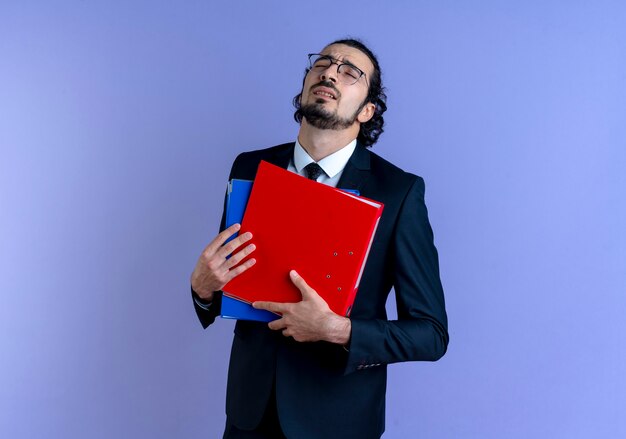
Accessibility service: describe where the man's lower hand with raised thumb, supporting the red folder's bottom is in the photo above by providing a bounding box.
[252,270,352,346]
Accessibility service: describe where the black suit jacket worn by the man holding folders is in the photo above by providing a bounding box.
[195,143,448,439]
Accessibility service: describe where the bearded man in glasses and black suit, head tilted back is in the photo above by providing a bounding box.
[191,39,448,439]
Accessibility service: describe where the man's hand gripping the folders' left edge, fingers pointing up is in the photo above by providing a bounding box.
[191,224,256,301]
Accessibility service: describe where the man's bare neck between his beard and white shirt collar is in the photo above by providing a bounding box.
[298,119,360,162]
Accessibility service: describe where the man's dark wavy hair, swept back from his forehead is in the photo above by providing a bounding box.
[293,38,387,147]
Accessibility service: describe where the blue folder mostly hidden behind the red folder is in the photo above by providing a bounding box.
[220,179,359,322]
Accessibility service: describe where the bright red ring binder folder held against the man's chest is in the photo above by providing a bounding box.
[223,162,383,316]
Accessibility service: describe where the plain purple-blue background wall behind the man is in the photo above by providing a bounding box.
[0,0,626,439]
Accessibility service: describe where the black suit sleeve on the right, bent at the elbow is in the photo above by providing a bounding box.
[345,177,449,374]
